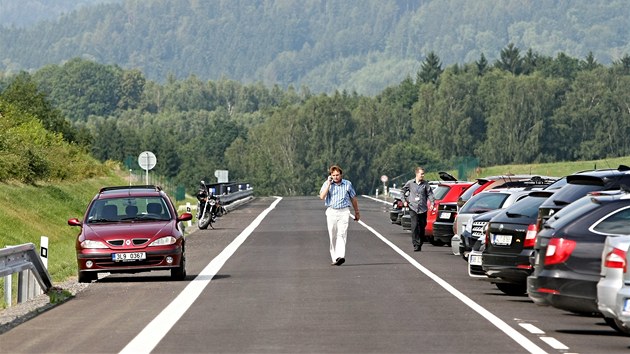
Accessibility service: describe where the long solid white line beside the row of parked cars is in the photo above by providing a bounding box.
[359,220,547,353]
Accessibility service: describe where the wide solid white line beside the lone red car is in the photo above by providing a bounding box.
[120,197,282,354]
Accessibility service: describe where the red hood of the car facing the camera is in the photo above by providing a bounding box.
[83,221,174,240]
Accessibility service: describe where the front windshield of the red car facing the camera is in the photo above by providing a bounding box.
[87,197,171,223]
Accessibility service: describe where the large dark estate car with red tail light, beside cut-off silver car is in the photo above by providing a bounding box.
[527,191,630,314]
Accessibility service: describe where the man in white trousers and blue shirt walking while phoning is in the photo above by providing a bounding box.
[319,165,360,266]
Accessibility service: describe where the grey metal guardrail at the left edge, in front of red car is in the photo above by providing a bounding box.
[0,243,53,306]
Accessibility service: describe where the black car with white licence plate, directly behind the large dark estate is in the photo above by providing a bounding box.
[486,190,554,295]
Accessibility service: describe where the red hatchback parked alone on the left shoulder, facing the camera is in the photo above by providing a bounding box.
[68,185,192,283]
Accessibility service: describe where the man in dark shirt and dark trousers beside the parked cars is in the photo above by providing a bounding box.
[403,166,435,252]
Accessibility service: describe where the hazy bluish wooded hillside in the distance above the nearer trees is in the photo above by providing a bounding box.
[0,0,630,94]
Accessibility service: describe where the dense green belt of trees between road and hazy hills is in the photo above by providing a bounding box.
[0,44,630,195]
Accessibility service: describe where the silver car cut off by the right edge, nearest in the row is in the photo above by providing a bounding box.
[597,235,630,334]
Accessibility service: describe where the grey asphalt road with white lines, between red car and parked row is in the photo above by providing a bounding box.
[0,197,630,353]
